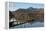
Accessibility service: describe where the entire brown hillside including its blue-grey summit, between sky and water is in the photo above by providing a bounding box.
[9,7,44,22]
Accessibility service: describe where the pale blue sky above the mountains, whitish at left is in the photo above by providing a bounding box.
[8,2,44,11]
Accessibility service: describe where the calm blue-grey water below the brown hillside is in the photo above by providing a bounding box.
[11,22,44,29]
